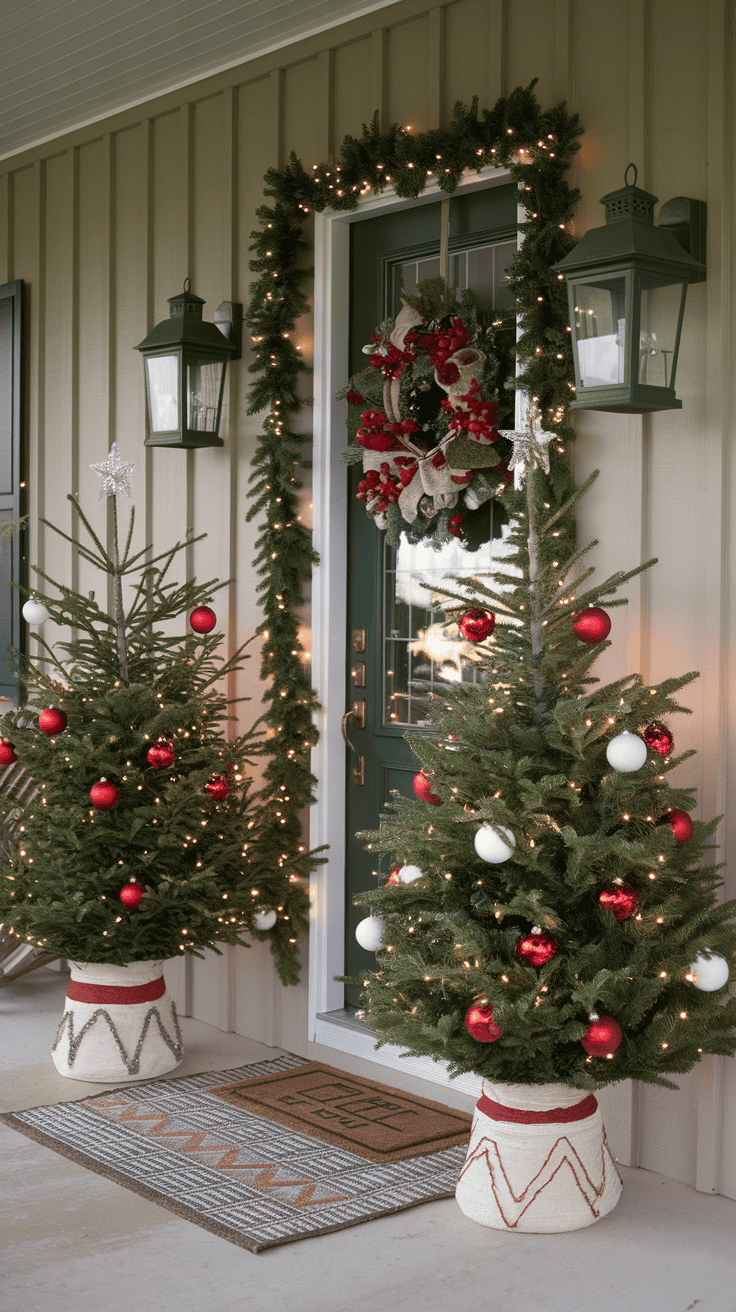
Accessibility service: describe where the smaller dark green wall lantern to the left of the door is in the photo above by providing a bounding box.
[135,278,243,449]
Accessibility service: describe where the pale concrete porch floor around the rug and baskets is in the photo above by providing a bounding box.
[0,970,736,1312]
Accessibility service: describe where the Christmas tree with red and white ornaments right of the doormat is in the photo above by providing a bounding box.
[348,408,736,1090]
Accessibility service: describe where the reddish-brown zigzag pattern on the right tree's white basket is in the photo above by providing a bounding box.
[458,1127,621,1229]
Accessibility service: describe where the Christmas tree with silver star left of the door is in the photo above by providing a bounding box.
[0,445,307,983]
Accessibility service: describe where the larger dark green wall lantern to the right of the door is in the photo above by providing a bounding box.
[552,164,706,415]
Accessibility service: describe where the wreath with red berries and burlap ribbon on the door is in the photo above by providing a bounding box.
[344,278,514,550]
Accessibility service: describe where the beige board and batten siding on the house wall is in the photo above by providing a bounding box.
[0,0,736,1198]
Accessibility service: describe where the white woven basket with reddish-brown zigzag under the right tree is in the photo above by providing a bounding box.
[455,1080,622,1235]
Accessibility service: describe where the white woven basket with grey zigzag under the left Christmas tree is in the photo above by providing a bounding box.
[51,962,184,1084]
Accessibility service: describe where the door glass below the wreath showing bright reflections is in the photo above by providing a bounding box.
[383,512,509,728]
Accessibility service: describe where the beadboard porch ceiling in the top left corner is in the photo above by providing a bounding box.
[0,0,394,159]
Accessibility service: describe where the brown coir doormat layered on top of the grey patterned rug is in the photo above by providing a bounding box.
[210,1061,471,1161]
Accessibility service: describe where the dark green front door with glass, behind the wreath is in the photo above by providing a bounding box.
[344,185,517,1006]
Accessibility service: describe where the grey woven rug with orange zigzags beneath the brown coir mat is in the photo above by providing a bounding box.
[0,1056,471,1253]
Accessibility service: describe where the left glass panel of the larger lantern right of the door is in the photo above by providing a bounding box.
[572,274,627,387]
